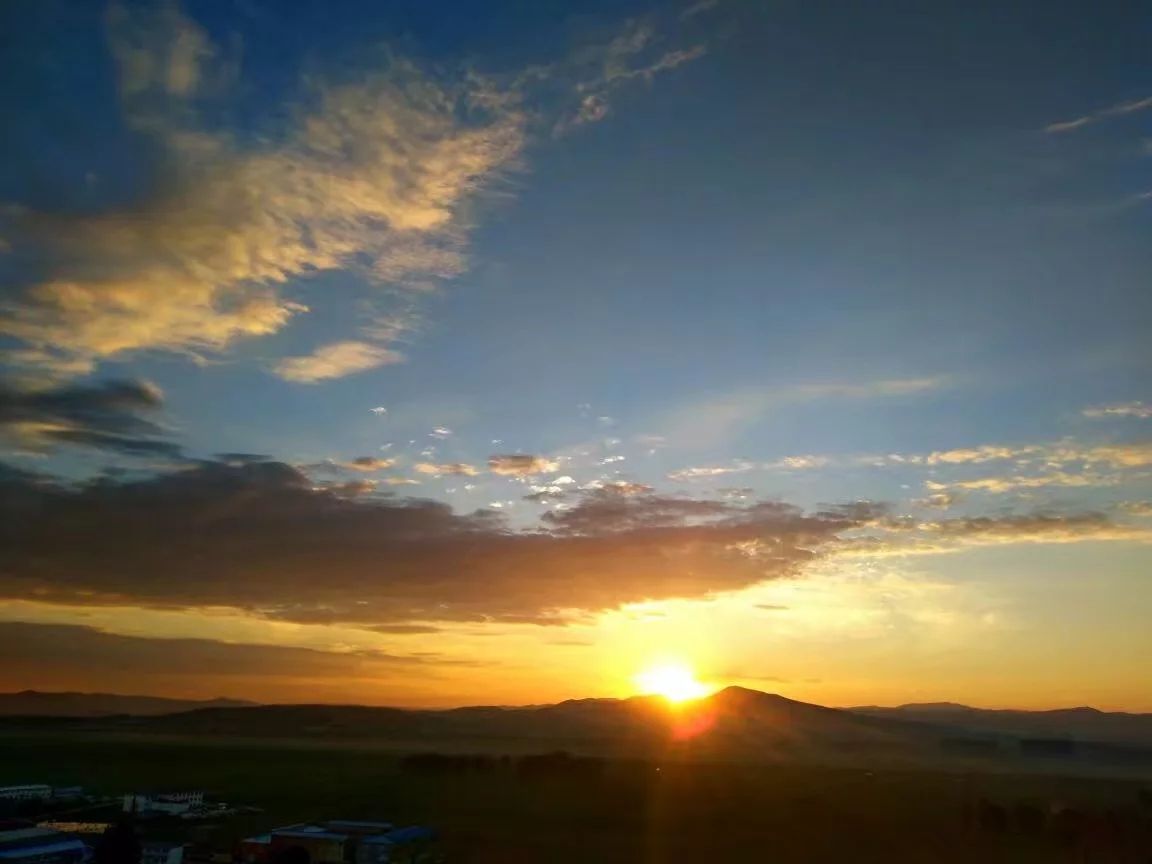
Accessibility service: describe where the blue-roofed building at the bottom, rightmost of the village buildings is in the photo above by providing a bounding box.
[236,819,435,864]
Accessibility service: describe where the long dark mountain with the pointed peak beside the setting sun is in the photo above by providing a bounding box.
[0,687,938,760]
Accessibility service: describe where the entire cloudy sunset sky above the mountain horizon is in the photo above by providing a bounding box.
[0,0,1152,712]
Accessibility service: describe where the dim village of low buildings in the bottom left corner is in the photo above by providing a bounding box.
[0,783,444,864]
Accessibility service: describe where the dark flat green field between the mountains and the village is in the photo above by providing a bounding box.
[0,735,1150,864]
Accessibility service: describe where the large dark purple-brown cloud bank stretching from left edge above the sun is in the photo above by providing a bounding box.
[0,462,863,624]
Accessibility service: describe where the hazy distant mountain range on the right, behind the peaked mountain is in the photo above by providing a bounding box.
[847,703,1152,746]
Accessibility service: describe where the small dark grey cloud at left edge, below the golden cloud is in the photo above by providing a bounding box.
[0,380,181,457]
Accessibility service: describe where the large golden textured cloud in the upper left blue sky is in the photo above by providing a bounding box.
[0,5,524,382]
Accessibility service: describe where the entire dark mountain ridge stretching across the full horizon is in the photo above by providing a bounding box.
[0,687,1152,771]
